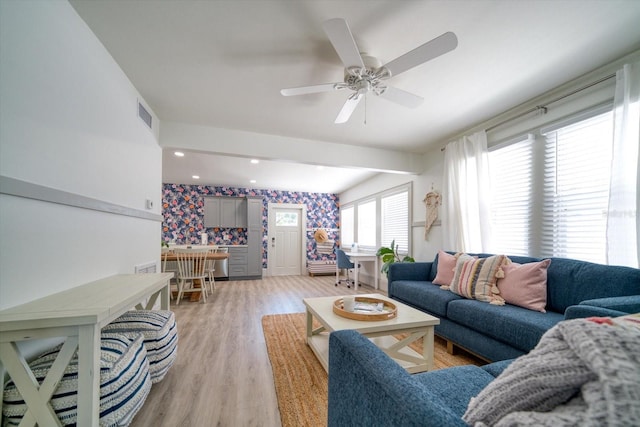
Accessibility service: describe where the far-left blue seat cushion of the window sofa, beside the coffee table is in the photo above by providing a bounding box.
[393,280,462,316]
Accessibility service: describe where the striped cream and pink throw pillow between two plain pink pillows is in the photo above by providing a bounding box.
[443,254,507,304]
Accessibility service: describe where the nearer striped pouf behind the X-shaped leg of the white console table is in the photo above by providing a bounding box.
[2,333,151,427]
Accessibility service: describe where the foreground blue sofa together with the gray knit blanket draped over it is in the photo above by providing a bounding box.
[327,309,640,427]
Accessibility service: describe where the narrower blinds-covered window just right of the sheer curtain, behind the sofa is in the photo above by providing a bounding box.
[489,135,537,255]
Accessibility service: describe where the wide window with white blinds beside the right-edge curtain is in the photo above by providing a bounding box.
[541,111,613,263]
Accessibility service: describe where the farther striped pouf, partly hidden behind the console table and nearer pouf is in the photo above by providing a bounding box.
[102,310,178,384]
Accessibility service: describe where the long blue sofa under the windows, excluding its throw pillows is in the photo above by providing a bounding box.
[388,252,640,361]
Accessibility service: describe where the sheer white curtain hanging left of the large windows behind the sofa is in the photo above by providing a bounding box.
[442,131,491,252]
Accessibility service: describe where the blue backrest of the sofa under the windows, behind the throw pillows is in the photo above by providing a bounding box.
[429,251,640,313]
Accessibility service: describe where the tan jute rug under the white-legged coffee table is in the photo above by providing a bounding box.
[262,313,482,427]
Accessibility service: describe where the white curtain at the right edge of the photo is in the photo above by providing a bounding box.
[607,62,640,268]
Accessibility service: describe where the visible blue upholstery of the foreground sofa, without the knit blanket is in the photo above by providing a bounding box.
[327,330,511,427]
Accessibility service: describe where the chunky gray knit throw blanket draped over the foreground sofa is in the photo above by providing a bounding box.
[463,317,640,427]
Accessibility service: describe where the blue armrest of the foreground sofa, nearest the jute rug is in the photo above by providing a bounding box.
[327,330,466,427]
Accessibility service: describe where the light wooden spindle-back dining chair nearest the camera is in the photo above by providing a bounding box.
[174,248,209,304]
